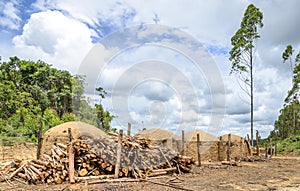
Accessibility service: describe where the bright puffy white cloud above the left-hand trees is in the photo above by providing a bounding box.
[13,11,93,72]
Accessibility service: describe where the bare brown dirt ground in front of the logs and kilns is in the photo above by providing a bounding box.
[0,156,300,191]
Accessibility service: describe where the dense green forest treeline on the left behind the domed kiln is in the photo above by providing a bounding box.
[0,57,114,141]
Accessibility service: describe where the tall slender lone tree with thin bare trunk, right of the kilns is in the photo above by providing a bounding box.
[229,4,263,145]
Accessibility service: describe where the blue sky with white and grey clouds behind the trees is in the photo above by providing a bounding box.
[0,0,300,138]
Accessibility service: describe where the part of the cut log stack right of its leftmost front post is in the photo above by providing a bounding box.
[74,136,195,178]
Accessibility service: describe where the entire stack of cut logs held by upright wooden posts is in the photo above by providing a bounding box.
[0,133,195,184]
